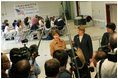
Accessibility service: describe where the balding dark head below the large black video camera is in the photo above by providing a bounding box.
[10,59,31,78]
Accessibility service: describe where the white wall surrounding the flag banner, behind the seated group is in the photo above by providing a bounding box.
[1,1,59,23]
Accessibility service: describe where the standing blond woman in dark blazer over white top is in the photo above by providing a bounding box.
[74,26,93,65]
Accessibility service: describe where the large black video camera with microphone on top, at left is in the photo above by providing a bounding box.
[10,39,38,64]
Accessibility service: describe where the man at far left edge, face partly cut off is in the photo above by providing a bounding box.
[1,53,10,78]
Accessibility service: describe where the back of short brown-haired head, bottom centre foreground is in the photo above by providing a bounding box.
[44,58,60,78]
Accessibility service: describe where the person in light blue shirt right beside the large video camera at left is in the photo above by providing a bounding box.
[29,44,41,78]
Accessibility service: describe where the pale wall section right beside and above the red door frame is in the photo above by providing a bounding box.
[92,1,117,28]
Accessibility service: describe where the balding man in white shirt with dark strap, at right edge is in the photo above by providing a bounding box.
[97,33,117,78]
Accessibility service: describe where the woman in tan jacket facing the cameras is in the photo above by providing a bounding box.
[50,30,66,56]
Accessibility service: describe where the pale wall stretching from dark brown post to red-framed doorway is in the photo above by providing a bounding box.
[74,1,117,28]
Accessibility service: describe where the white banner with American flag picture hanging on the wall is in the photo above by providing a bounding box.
[15,3,39,17]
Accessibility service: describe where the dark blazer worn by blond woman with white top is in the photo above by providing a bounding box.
[74,34,93,63]
